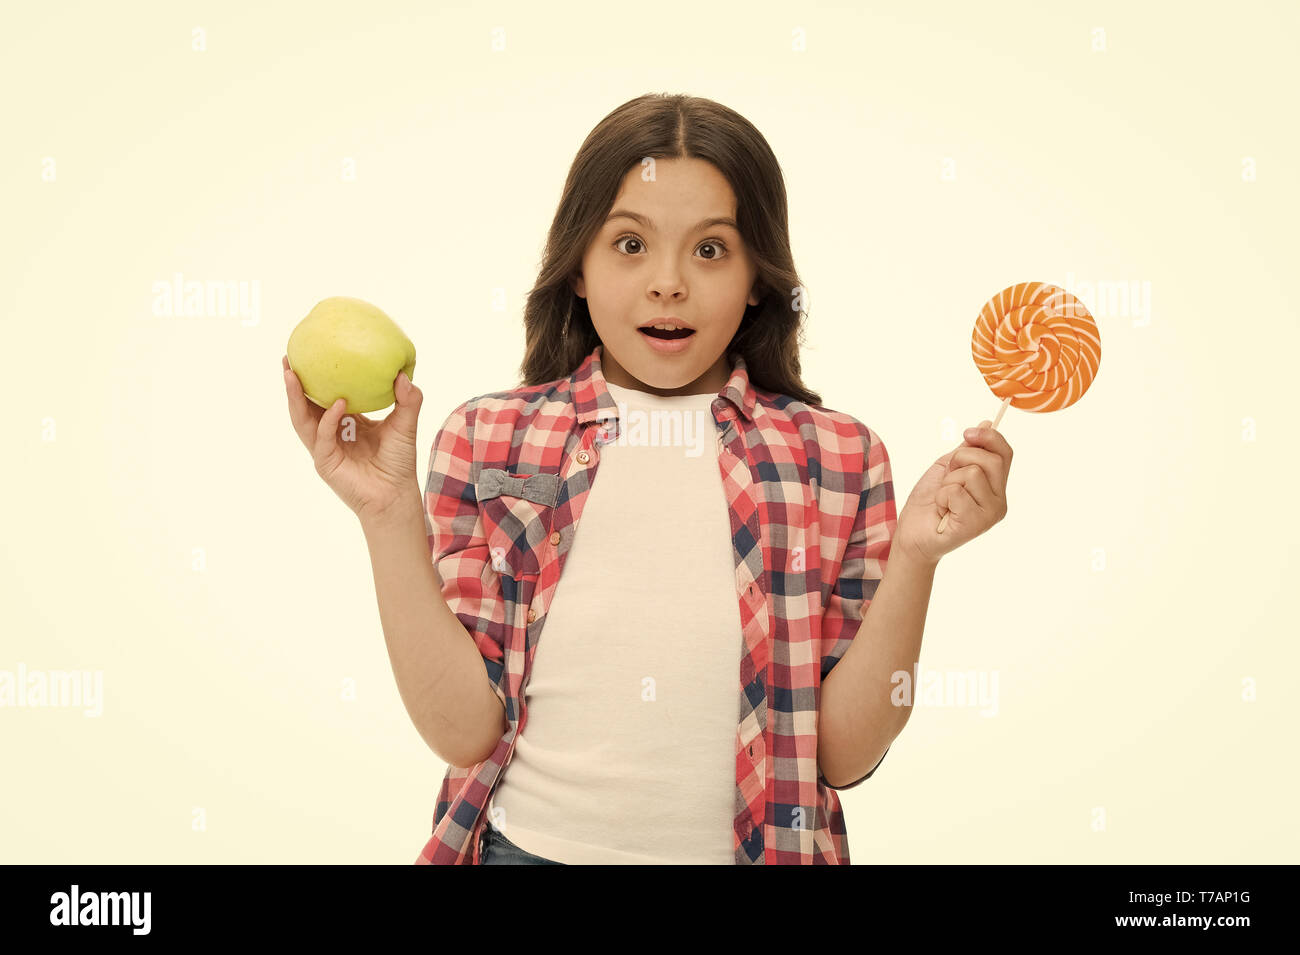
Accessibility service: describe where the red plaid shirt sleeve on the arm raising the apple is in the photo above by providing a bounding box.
[424,399,506,706]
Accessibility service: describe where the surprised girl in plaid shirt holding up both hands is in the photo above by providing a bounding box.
[285,95,1011,864]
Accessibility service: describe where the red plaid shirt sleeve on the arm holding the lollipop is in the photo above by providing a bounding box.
[818,422,898,790]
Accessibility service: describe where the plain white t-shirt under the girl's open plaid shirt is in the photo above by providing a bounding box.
[488,382,744,865]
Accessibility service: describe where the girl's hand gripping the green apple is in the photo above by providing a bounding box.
[282,355,424,521]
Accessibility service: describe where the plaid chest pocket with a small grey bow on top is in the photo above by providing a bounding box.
[475,468,559,579]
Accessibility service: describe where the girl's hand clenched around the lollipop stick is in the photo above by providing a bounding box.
[893,421,1011,564]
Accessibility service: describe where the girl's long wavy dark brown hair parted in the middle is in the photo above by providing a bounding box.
[520,94,822,405]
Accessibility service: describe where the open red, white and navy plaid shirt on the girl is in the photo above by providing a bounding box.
[416,346,897,865]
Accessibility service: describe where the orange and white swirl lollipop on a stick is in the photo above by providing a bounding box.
[939,282,1101,534]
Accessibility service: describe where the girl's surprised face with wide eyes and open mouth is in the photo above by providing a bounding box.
[573,159,759,396]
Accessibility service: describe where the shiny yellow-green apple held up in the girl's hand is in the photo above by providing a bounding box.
[285,296,415,414]
